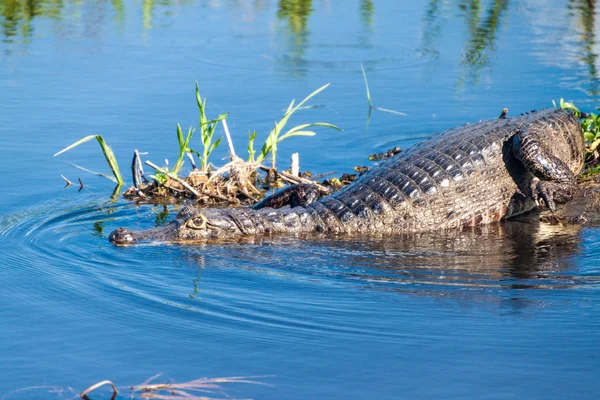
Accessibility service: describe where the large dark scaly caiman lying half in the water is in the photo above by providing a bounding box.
[109,109,584,245]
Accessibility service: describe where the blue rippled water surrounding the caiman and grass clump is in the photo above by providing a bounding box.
[0,0,600,399]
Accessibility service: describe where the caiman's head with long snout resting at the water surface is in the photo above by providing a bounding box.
[108,206,241,246]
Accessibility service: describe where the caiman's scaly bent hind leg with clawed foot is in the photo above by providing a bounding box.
[512,124,577,211]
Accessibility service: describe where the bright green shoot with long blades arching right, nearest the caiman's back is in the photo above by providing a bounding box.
[248,83,342,168]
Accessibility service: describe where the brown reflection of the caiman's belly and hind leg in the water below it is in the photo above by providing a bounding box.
[312,221,580,288]
